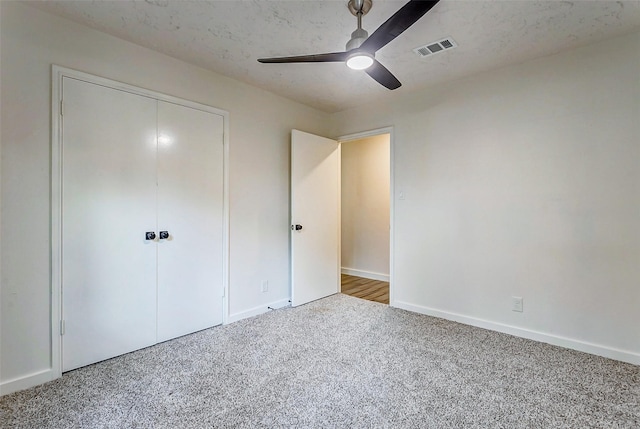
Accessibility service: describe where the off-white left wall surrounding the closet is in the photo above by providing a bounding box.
[0,2,328,393]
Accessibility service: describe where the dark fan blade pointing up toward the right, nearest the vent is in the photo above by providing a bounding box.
[360,0,440,53]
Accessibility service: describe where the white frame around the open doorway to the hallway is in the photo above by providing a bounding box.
[335,126,395,307]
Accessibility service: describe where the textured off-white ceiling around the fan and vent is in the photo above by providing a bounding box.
[30,0,640,112]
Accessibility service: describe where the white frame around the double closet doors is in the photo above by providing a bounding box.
[50,64,229,380]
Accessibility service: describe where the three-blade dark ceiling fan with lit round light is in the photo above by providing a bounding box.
[258,0,440,89]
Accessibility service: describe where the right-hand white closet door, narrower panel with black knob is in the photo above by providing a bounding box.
[158,101,224,341]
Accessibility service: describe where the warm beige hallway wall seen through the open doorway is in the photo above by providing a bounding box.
[341,134,390,281]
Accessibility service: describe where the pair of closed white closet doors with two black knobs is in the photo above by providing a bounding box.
[60,76,224,371]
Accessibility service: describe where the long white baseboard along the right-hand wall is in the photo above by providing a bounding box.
[391,301,640,365]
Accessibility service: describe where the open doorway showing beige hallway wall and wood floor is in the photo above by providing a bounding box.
[340,129,392,304]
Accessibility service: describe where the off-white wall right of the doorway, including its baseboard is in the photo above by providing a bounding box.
[333,34,640,364]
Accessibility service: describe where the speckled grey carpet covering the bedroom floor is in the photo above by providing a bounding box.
[0,294,640,429]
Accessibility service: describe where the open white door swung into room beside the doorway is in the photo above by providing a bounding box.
[291,130,340,307]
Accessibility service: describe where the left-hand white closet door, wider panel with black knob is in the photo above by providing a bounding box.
[62,78,157,371]
